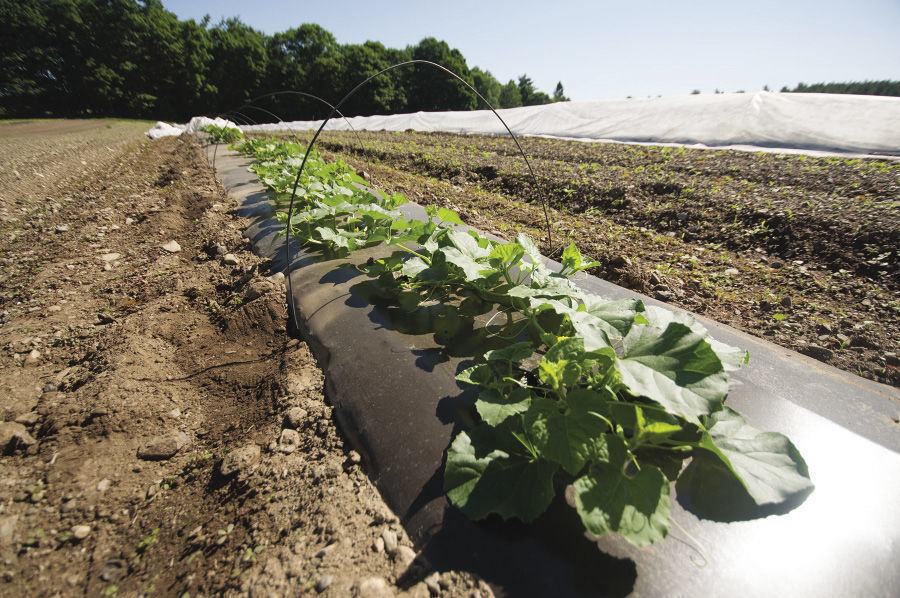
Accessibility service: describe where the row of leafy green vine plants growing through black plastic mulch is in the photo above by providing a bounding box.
[213,132,812,546]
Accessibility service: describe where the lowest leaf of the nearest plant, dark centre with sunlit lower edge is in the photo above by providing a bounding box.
[574,463,669,546]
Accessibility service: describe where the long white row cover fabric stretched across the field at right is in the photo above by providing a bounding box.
[241,91,900,155]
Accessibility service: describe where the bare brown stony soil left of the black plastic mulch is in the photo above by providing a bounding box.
[0,121,491,598]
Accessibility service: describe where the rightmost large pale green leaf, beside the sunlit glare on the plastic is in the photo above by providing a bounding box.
[699,407,812,505]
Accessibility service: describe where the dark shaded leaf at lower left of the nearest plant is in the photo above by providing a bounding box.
[444,428,559,522]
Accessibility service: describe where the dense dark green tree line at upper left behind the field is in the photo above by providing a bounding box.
[0,0,568,122]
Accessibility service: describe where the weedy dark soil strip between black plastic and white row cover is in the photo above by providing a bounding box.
[292,131,900,387]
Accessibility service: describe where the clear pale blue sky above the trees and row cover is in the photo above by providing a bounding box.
[162,0,900,100]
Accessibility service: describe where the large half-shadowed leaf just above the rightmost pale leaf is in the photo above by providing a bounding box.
[614,322,728,424]
